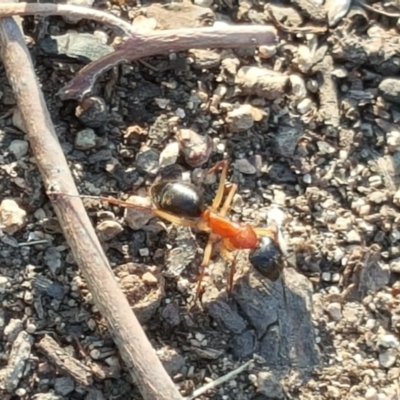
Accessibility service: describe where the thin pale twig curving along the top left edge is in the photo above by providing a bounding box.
[0,3,136,35]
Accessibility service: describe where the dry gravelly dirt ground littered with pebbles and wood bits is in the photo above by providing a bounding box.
[0,0,400,400]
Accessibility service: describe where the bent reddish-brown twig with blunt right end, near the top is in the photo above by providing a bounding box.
[59,25,277,100]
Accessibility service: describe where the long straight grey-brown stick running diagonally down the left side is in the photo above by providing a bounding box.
[0,14,182,400]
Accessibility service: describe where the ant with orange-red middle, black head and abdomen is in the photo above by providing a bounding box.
[52,160,287,299]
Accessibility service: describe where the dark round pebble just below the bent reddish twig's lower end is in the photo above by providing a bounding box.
[75,96,108,128]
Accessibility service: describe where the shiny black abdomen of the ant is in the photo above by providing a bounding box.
[150,181,203,218]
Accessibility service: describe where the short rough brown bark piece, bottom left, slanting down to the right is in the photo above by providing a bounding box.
[37,335,93,386]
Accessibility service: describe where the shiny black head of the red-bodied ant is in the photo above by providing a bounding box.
[249,236,283,282]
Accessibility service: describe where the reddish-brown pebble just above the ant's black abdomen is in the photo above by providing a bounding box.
[176,129,213,168]
